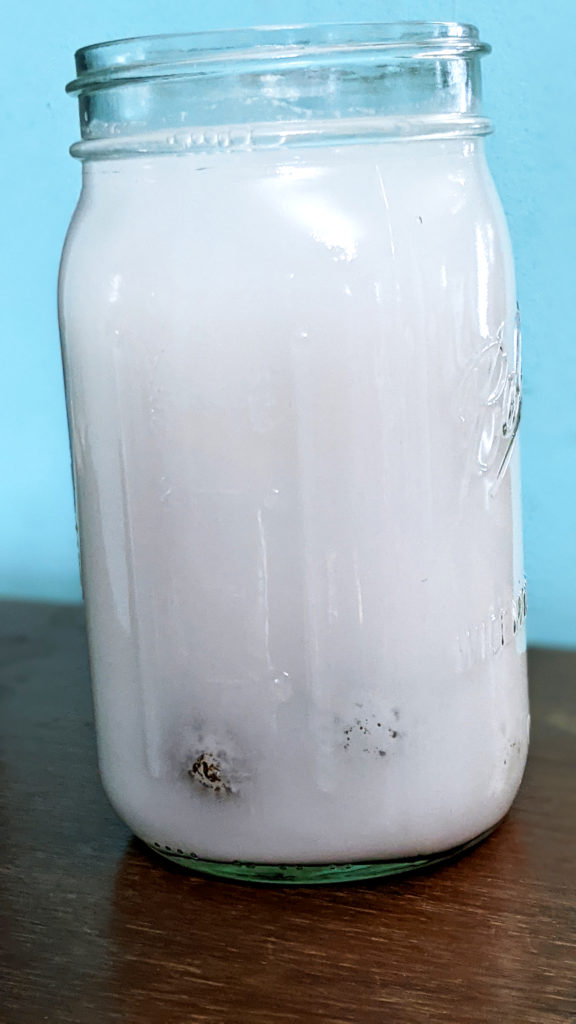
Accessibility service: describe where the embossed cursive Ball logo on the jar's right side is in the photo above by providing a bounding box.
[460,313,522,494]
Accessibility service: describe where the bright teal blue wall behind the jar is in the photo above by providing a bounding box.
[0,0,576,645]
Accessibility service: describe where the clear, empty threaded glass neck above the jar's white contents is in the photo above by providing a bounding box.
[68,23,490,159]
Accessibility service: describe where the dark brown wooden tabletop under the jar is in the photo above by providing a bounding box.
[0,603,576,1024]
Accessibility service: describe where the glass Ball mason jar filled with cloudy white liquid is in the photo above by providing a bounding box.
[60,23,529,883]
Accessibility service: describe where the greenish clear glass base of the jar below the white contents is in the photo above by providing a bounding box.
[147,822,499,886]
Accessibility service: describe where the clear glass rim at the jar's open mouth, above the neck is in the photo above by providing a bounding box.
[67,22,490,94]
